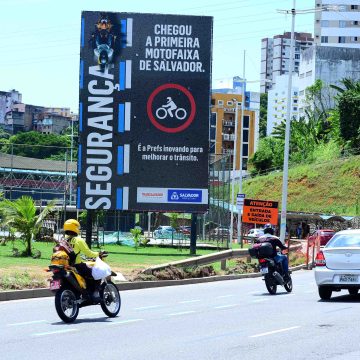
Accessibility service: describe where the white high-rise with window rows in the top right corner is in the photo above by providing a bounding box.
[314,0,360,48]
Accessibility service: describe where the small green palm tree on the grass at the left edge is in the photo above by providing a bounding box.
[0,196,54,256]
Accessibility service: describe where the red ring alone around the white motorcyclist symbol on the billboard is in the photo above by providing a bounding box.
[146,84,196,133]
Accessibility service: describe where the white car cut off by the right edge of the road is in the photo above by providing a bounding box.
[315,229,360,300]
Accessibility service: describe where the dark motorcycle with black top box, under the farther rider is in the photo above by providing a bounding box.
[249,242,293,295]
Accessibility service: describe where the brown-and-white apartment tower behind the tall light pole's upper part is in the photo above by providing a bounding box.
[260,32,314,93]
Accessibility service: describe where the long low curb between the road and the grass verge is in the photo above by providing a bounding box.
[0,264,307,302]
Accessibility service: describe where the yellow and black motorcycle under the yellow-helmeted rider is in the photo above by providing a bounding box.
[46,250,121,323]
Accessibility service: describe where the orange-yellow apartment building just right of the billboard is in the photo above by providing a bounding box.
[209,93,257,170]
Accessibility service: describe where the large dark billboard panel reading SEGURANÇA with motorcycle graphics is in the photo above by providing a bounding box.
[77,11,212,212]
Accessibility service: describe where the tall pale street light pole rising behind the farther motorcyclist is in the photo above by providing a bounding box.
[280,0,296,243]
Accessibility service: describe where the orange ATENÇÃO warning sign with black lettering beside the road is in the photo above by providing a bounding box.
[242,199,279,225]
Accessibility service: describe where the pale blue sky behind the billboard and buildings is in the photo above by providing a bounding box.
[0,0,315,113]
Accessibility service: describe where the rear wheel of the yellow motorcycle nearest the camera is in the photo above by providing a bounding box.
[55,288,79,323]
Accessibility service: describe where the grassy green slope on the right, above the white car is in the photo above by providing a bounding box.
[235,156,360,216]
